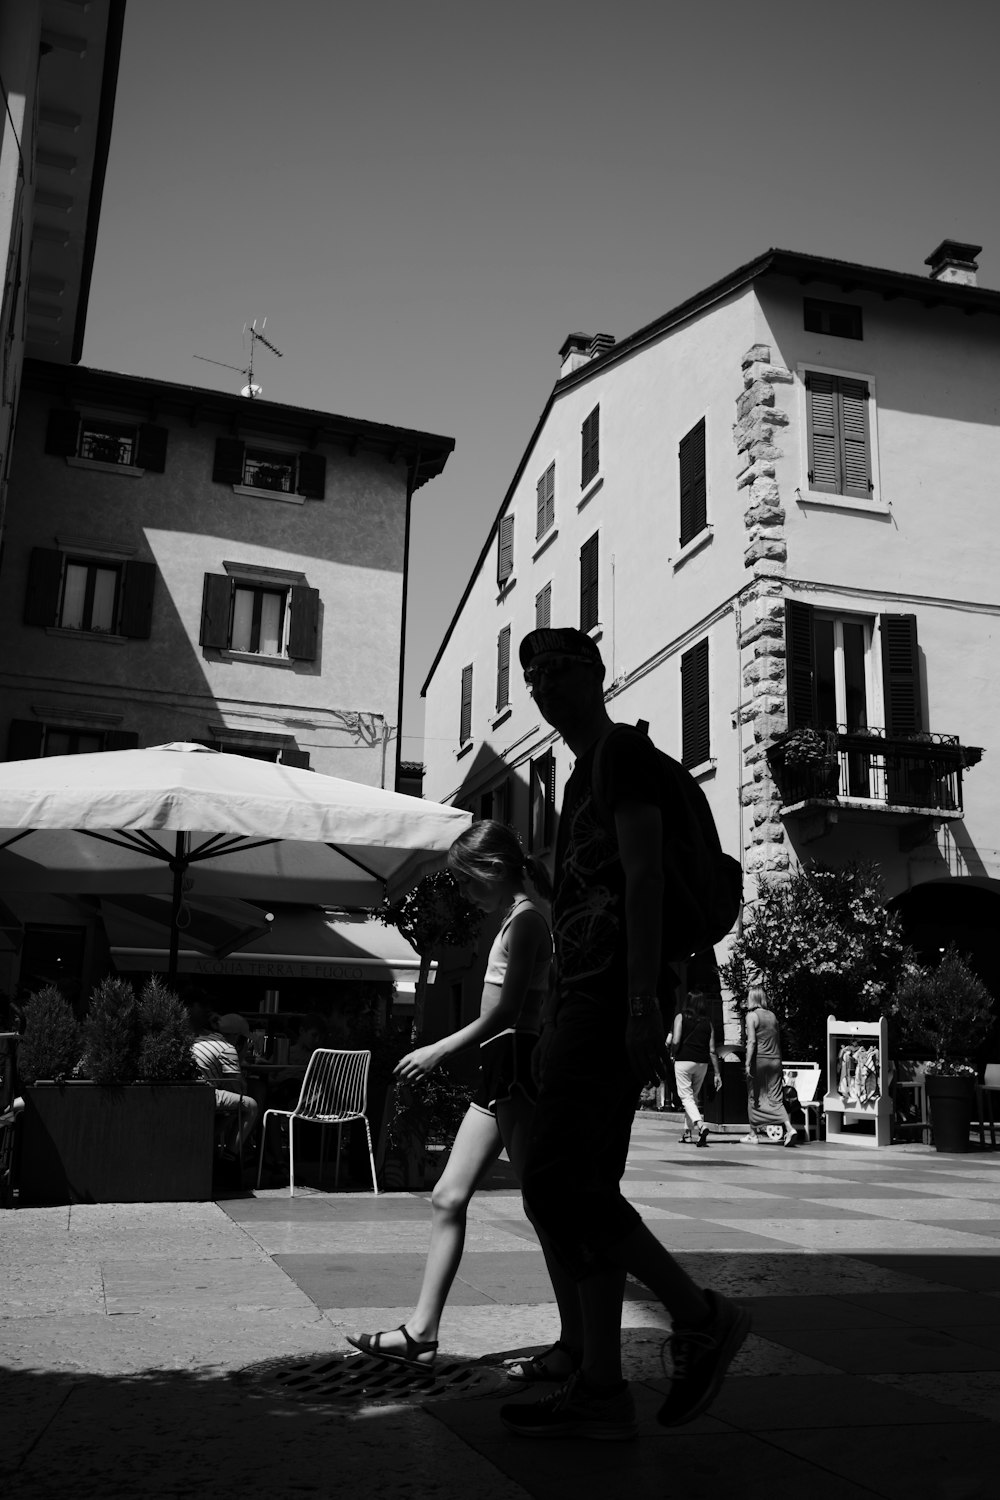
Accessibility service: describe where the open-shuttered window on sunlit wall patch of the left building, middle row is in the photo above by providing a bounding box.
[199,564,319,662]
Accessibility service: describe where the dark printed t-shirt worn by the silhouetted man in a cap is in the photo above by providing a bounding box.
[552,732,663,1014]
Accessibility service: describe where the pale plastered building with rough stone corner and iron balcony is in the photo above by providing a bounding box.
[424,242,1000,1026]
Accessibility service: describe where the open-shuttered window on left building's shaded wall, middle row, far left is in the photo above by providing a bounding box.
[24,548,156,641]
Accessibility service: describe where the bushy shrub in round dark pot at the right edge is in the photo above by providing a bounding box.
[892,944,994,1151]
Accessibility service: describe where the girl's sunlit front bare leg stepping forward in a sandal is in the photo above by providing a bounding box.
[370,1109,502,1353]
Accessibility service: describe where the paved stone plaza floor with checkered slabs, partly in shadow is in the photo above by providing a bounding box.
[0,1115,1000,1500]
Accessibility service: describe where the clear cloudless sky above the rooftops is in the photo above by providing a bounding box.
[84,0,1000,759]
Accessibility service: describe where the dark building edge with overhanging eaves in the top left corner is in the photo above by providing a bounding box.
[0,0,124,548]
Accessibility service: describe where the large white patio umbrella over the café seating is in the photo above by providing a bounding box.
[0,744,469,975]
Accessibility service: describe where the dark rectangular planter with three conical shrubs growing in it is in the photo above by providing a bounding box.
[18,978,214,1203]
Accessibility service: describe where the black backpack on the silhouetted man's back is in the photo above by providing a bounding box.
[591,725,744,963]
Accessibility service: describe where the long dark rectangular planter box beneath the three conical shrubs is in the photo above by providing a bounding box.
[18,1083,216,1205]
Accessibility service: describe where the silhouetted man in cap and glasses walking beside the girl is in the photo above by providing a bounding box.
[501,629,750,1440]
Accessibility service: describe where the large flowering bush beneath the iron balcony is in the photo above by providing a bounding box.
[720,861,913,1058]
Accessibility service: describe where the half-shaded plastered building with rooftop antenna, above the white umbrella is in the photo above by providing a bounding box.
[0,360,453,788]
